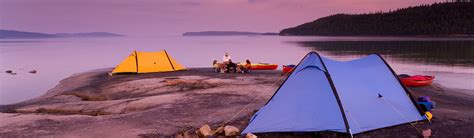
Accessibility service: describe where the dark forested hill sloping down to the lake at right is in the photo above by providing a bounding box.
[280,2,474,36]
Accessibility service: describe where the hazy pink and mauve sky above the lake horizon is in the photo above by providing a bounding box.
[0,0,442,36]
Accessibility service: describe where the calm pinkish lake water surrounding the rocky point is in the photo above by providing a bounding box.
[0,36,474,104]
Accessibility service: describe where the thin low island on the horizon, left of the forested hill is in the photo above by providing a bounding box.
[183,31,278,36]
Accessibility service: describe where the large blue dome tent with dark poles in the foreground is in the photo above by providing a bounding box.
[242,52,426,135]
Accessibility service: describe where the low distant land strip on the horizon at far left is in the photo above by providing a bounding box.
[0,29,125,39]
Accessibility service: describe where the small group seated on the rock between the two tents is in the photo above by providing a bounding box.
[212,53,252,73]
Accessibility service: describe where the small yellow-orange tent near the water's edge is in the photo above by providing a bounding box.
[111,50,186,75]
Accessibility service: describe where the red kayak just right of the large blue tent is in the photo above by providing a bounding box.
[398,74,434,87]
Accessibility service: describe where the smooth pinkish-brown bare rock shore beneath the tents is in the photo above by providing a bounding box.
[0,68,474,137]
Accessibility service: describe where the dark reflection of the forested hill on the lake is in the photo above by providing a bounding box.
[295,41,474,67]
